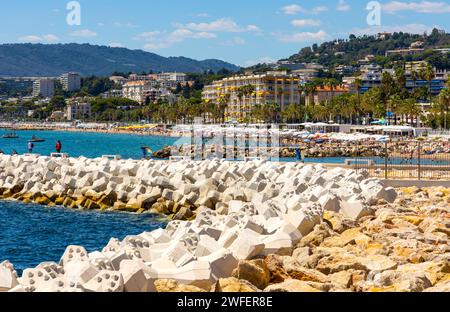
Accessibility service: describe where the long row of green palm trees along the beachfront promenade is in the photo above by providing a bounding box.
[135,66,450,128]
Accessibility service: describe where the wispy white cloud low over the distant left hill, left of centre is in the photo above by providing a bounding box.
[138,28,217,50]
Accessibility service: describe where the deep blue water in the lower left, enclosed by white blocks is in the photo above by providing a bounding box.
[0,201,166,274]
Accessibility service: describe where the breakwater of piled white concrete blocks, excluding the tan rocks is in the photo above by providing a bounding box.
[0,155,404,291]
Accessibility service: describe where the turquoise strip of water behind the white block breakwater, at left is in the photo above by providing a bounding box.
[0,130,187,159]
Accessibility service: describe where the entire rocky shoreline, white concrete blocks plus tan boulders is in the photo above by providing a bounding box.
[0,155,450,292]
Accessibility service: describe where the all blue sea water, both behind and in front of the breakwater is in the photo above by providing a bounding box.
[0,130,444,273]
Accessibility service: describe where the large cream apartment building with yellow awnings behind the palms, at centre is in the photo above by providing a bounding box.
[202,72,302,122]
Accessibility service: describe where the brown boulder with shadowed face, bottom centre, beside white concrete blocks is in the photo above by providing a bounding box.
[232,259,270,289]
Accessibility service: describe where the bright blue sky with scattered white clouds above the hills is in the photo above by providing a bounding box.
[0,0,450,66]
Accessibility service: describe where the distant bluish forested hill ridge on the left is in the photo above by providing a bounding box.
[0,43,239,77]
